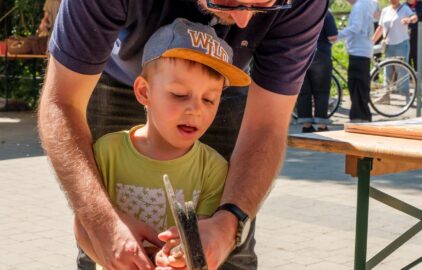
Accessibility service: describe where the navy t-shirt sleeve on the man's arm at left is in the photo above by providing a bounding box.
[49,0,127,75]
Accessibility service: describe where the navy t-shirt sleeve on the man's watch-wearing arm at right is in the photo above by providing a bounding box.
[251,0,328,95]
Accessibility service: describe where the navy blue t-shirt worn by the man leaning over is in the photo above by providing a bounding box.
[49,0,327,95]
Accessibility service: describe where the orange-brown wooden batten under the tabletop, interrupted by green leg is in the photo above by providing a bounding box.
[345,155,422,177]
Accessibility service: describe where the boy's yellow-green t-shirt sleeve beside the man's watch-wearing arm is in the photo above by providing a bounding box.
[196,156,228,216]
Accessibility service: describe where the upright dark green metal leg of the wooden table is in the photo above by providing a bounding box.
[354,158,372,270]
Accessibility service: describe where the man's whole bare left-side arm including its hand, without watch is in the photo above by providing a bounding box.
[38,57,160,269]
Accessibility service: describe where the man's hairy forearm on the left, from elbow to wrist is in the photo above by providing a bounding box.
[39,101,116,228]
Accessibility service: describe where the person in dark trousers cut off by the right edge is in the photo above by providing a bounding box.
[406,0,422,71]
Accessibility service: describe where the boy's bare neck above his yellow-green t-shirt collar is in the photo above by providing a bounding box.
[130,125,193,160]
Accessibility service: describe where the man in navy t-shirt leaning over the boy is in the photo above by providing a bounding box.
[39,0,327,269]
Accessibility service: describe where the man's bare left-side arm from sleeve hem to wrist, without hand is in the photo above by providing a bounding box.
[38,57,112,222]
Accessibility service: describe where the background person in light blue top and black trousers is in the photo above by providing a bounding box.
[338,0,376,122]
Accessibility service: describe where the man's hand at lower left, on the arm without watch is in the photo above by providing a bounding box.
[85,210,163,270]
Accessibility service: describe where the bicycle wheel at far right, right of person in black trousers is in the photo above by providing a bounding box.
[369,59,416,117]
